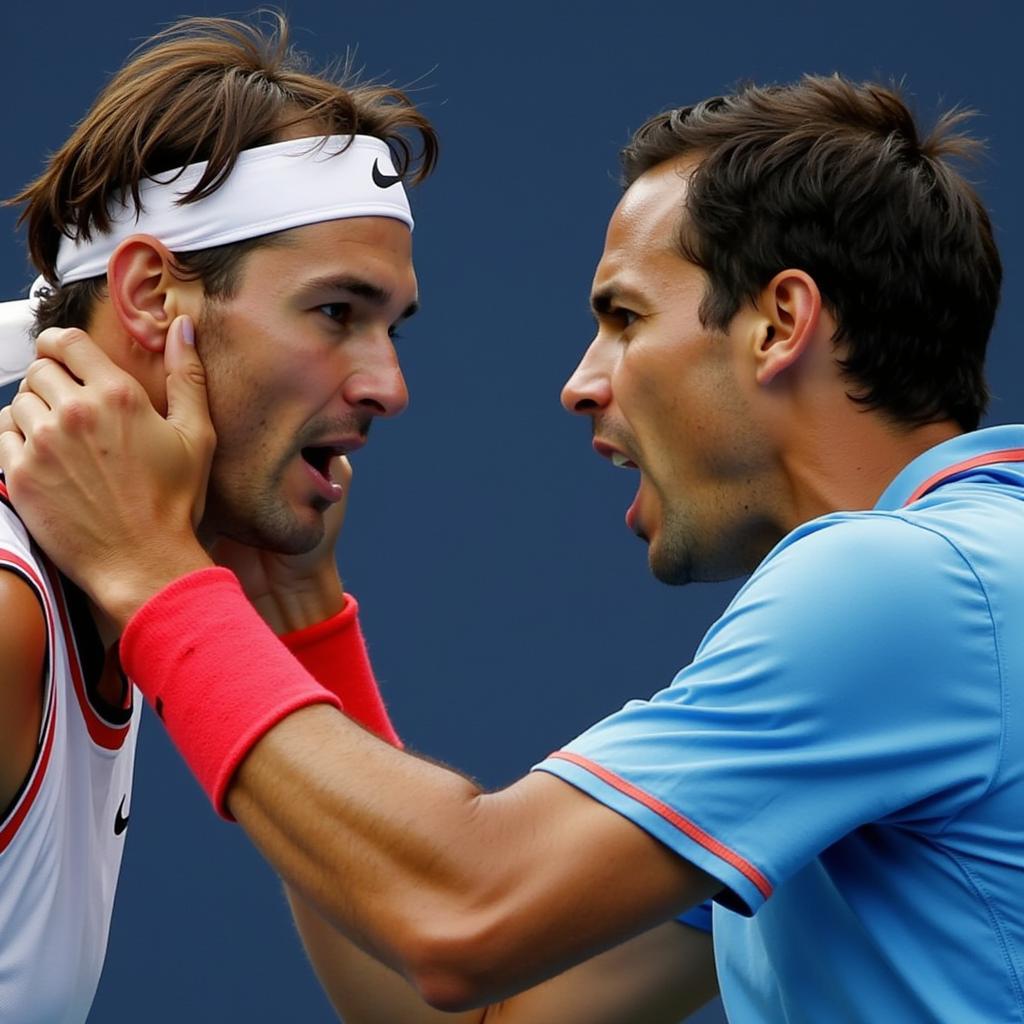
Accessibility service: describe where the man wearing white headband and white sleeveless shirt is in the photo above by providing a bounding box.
[0,19,437,1024]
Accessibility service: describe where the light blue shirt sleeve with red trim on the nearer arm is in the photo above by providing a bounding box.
[536,513,1001,913]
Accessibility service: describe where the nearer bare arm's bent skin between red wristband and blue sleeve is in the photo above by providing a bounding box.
[229,707,720,1010]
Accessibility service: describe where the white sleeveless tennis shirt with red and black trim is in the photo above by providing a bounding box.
[0,482,141,1024]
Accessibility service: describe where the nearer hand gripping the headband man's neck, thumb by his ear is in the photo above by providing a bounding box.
[0,316,215,626]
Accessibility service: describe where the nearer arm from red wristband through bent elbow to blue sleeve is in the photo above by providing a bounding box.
[122,569,717,1009]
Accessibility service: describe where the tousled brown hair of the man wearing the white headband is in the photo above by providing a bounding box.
[8,12,438,330]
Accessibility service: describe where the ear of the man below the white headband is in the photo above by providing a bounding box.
[106,234,202,352]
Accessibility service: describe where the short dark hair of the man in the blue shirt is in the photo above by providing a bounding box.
[622,75,1002,430]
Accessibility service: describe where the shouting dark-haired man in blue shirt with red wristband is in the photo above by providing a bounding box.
[0,77,1024,1024]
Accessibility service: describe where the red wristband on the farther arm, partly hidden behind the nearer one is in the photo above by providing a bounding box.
[281,594,402,749]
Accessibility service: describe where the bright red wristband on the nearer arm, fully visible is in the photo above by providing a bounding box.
[121,568,341,821]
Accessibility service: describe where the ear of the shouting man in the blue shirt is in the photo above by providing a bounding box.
[755,269,821,384]
